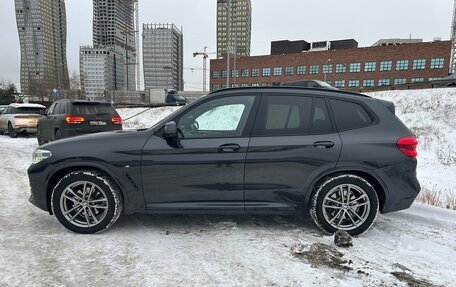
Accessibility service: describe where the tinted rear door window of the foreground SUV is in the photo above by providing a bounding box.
[253,95,332,136]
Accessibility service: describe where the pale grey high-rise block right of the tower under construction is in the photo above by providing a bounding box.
[143,24,184,91]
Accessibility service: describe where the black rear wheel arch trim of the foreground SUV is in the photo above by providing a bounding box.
[305,168,388,212]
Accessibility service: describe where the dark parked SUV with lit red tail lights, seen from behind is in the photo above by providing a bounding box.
[37,100,122,145]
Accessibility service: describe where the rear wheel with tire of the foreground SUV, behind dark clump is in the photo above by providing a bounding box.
[310,174,379,235]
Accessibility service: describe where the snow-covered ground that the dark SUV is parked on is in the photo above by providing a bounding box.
[0,89,456,286]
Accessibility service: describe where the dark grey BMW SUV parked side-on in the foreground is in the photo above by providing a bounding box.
[28,87,420,235]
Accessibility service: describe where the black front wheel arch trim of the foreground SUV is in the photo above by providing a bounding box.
[46,164,126,215]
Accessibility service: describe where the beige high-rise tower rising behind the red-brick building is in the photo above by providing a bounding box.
[217,0,252,58]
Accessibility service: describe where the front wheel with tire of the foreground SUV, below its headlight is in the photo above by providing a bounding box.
[51,170,122,234]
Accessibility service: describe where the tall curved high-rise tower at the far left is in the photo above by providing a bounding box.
[15,0,69,94]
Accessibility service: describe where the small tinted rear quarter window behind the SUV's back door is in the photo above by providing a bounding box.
[331,100,373,131]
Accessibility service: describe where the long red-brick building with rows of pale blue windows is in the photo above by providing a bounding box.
[210,39,451,91]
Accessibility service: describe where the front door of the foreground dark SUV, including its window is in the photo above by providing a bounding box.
[142,94,258,211]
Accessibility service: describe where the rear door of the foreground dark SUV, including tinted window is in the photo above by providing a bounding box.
[245,93,341,213]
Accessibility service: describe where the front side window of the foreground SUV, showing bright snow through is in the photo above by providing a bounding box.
[177,96,255,138]
